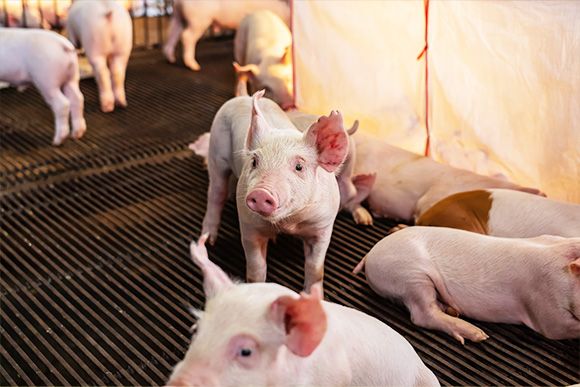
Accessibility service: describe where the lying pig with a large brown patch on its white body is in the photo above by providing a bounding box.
[415,189,580,238]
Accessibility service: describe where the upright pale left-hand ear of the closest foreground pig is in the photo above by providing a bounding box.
[189,233,233,299]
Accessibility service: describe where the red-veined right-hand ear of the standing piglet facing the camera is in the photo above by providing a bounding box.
[304,111,348,172]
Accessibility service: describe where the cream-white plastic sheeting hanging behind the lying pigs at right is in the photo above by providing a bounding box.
[293,0,580,202]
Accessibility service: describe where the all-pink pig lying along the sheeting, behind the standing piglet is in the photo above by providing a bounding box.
[288,112,541,224]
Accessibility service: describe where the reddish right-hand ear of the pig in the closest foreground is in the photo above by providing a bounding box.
[270,283,326,357]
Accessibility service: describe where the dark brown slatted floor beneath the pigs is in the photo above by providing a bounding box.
[0,41,580,385]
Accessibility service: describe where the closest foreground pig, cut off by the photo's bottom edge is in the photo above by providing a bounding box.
[167,235,439,386]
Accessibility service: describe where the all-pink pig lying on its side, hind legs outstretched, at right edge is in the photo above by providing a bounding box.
[354,226,580,343]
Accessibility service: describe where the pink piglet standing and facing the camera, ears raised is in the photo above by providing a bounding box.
[203,90,348,289]
